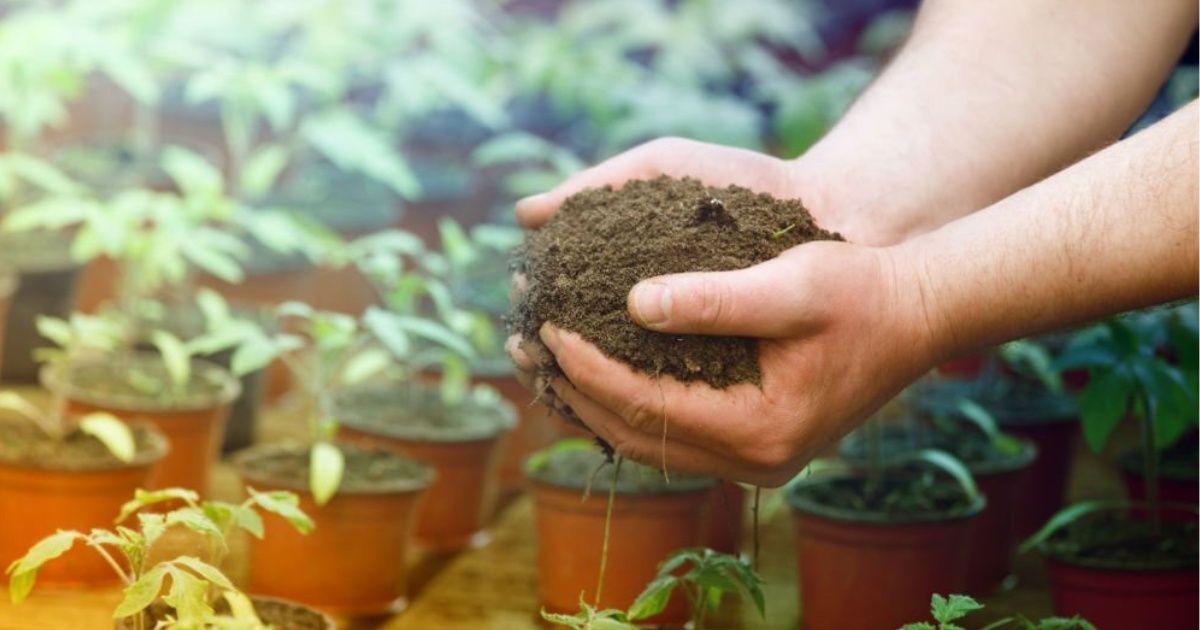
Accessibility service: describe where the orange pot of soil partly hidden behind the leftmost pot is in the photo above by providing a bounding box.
[42,353,240,494]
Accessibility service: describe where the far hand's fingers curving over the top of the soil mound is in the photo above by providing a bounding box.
[515,138,793,229]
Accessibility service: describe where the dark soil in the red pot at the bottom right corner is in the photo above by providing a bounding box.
[1039,512,1200,569]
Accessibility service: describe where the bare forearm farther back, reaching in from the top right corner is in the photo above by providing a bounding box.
[797,0,1196,244]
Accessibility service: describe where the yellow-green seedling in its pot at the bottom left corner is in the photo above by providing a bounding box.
[7,488,335,630]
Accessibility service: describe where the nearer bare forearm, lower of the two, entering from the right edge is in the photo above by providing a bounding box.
[892,102,1198,356]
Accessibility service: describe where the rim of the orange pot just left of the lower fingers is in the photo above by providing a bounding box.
[334,382,517,444]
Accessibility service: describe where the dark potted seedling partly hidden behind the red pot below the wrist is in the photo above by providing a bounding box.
[841,379,1037,594]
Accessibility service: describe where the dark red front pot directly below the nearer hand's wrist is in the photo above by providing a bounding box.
[788,479,984,630]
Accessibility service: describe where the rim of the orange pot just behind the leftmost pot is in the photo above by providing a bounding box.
[38,350,241,413]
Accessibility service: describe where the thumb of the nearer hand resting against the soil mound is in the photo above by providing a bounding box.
[628,257,814,337]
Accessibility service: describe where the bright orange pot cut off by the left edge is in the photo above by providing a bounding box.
[0,426,168,586]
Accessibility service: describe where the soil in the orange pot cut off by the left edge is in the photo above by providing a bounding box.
[0,419,167,470]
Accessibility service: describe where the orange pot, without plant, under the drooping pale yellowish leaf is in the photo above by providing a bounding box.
[233,446,430,616]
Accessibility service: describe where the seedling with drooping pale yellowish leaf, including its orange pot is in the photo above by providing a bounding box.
[226,302,432,616]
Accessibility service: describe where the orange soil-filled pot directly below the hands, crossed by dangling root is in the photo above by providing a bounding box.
[529,450,716,625]
